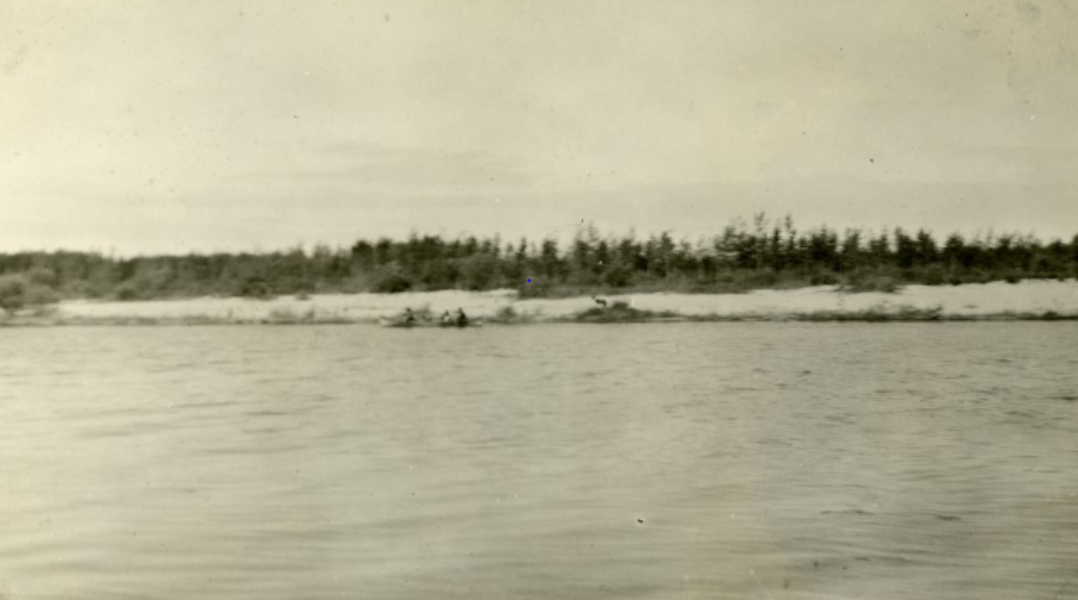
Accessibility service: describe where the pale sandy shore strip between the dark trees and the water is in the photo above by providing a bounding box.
[5,280,1078,325]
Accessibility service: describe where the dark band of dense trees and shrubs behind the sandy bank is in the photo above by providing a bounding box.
[0,214,1078,304]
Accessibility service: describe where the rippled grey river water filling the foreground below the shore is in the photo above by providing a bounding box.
[0,323,1078,600]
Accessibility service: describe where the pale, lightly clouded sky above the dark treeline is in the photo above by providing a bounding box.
[0,0,1078,255]
